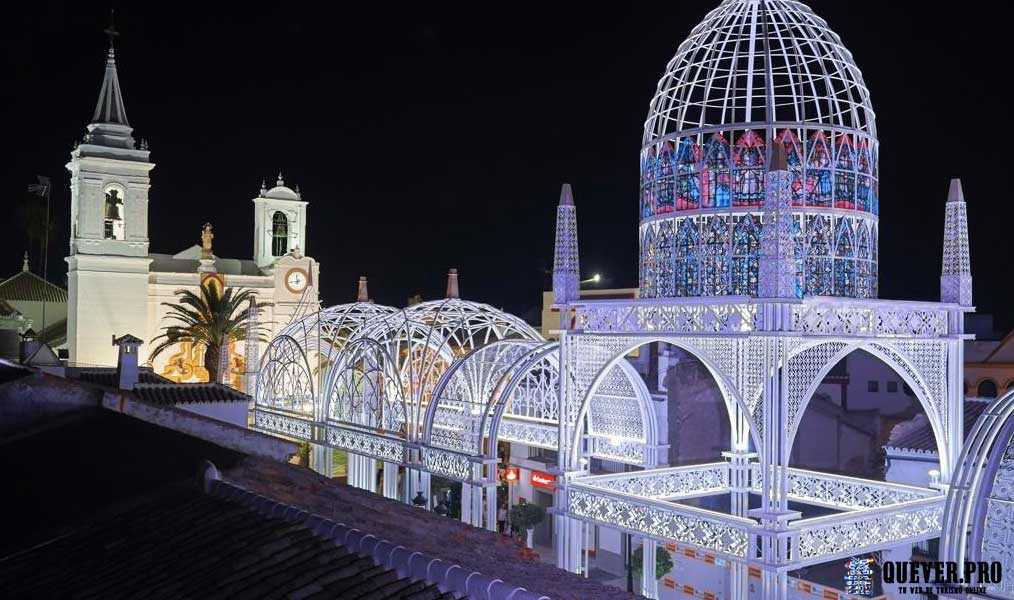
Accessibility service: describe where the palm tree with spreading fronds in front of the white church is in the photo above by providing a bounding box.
[149,286,267,382]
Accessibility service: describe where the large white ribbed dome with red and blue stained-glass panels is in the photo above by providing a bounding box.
[640,0,879,298]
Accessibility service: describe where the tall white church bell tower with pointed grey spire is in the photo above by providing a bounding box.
[66,25,155,365]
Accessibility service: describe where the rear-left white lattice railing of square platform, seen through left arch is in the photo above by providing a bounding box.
[577,462,729,500]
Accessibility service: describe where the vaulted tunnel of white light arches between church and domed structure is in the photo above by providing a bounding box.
[255,298,658,506]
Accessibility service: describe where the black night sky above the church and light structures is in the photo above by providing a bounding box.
[0,0,1014,326]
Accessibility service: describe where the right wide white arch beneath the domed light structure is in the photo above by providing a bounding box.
[786,340,951,473]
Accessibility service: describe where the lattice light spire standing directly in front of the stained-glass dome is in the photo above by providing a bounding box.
[757,141,802,298]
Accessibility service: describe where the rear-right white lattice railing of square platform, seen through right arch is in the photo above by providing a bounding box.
[750,463,942,511]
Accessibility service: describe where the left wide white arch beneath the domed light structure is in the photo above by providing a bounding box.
[570,336,764,464]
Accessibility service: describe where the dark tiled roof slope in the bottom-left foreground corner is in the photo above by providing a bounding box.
[0,484,452,600]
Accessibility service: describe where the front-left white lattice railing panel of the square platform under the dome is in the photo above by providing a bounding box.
[567,482,756,559]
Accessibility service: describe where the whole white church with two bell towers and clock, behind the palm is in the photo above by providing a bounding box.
[66,33,319,387]
